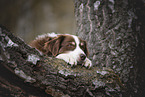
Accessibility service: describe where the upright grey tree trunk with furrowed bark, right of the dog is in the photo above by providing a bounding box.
[75,0,145,97]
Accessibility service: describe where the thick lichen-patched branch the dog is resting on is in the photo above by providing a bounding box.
[0,27,125,97]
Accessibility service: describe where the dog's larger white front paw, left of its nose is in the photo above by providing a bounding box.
[56,54,77,66]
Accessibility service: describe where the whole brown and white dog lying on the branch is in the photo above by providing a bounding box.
[30,33,92,68]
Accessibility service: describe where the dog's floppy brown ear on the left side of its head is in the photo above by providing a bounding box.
[44,35,65,56]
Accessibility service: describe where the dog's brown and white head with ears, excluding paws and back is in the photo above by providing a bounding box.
[44,35,88,64]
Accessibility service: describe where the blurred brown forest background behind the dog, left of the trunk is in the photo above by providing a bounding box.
[0,0,75,43]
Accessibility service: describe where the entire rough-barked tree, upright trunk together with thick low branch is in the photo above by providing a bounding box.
[0,0,145,97]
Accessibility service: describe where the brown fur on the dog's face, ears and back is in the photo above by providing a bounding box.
[30,35,88,56]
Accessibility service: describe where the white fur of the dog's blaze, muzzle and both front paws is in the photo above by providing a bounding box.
[56,35,92,68]
